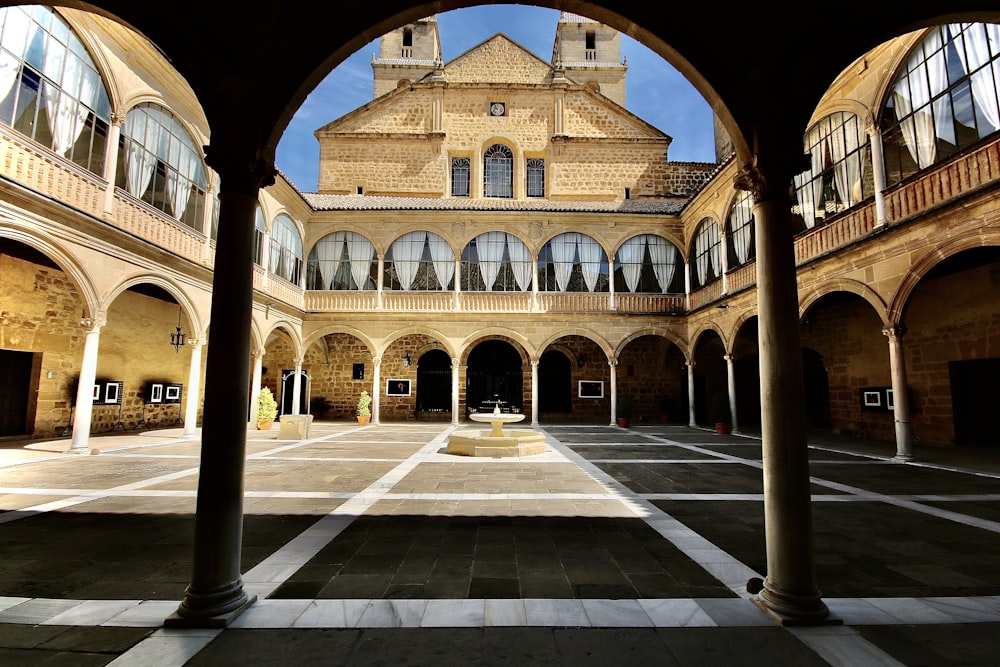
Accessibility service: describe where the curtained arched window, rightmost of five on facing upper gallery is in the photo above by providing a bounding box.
[615,234,684,294]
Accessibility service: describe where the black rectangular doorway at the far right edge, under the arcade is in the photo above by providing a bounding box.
[948,358,1000,446]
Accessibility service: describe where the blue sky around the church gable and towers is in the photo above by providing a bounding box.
[275,5,715,192]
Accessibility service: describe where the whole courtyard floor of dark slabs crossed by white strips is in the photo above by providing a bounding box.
[0,423,1000,667]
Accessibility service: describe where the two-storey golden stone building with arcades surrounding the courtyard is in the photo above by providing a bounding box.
[0,0,1000,628]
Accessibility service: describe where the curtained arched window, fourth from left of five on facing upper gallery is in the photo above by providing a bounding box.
[538,232,609,292]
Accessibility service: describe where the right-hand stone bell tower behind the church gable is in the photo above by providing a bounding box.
[552,12,628,106]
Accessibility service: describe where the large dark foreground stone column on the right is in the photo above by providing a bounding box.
[736,155,829,622]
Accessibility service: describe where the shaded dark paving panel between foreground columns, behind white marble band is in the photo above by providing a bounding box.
[270,516,735,599]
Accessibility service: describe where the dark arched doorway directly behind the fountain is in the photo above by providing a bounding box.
[465,340,524,412]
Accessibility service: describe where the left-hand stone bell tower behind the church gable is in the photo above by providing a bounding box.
[372,16,441,99]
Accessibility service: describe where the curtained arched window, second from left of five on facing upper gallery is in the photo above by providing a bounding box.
[384,231,455,291]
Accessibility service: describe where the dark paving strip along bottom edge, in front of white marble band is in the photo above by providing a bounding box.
[187,628,828,667]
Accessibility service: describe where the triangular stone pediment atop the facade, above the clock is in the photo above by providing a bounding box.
[444,33,552,84]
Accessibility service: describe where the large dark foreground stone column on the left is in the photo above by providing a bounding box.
[164,146,276,627]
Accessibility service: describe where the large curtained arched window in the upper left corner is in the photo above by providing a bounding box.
[0,6,111,176]
